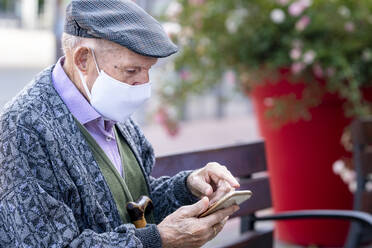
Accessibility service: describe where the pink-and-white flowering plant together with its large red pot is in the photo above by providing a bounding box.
[157,0,372,246]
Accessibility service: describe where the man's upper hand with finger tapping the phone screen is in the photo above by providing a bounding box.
[187,162,240,204]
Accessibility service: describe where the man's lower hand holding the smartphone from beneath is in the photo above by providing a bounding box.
[158,197,239,248]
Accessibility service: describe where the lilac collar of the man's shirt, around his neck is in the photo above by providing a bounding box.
[52,57,115,133]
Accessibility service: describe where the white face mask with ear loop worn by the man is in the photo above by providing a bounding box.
[76,49,151,122]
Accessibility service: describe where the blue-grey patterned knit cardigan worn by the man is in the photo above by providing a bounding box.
[0,66,196,248]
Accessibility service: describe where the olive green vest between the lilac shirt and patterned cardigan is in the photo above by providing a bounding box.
[75,120,154,223]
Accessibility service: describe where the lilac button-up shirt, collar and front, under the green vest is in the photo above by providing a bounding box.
[52,57,123,176]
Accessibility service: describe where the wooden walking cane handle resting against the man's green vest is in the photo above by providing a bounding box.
[127,195,154,228]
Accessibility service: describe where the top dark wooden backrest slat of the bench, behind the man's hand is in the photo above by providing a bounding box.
[152,141,266,177]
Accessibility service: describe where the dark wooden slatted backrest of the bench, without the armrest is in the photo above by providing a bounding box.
[152,141,272,247]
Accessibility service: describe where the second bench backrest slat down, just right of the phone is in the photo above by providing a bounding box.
[233,177,272,217]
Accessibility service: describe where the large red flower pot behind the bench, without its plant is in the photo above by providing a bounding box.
[250,73,352,247]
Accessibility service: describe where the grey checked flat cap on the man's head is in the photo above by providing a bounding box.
[64,0,178,58]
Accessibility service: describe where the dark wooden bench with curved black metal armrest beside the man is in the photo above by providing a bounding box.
[153,139,372,248]
